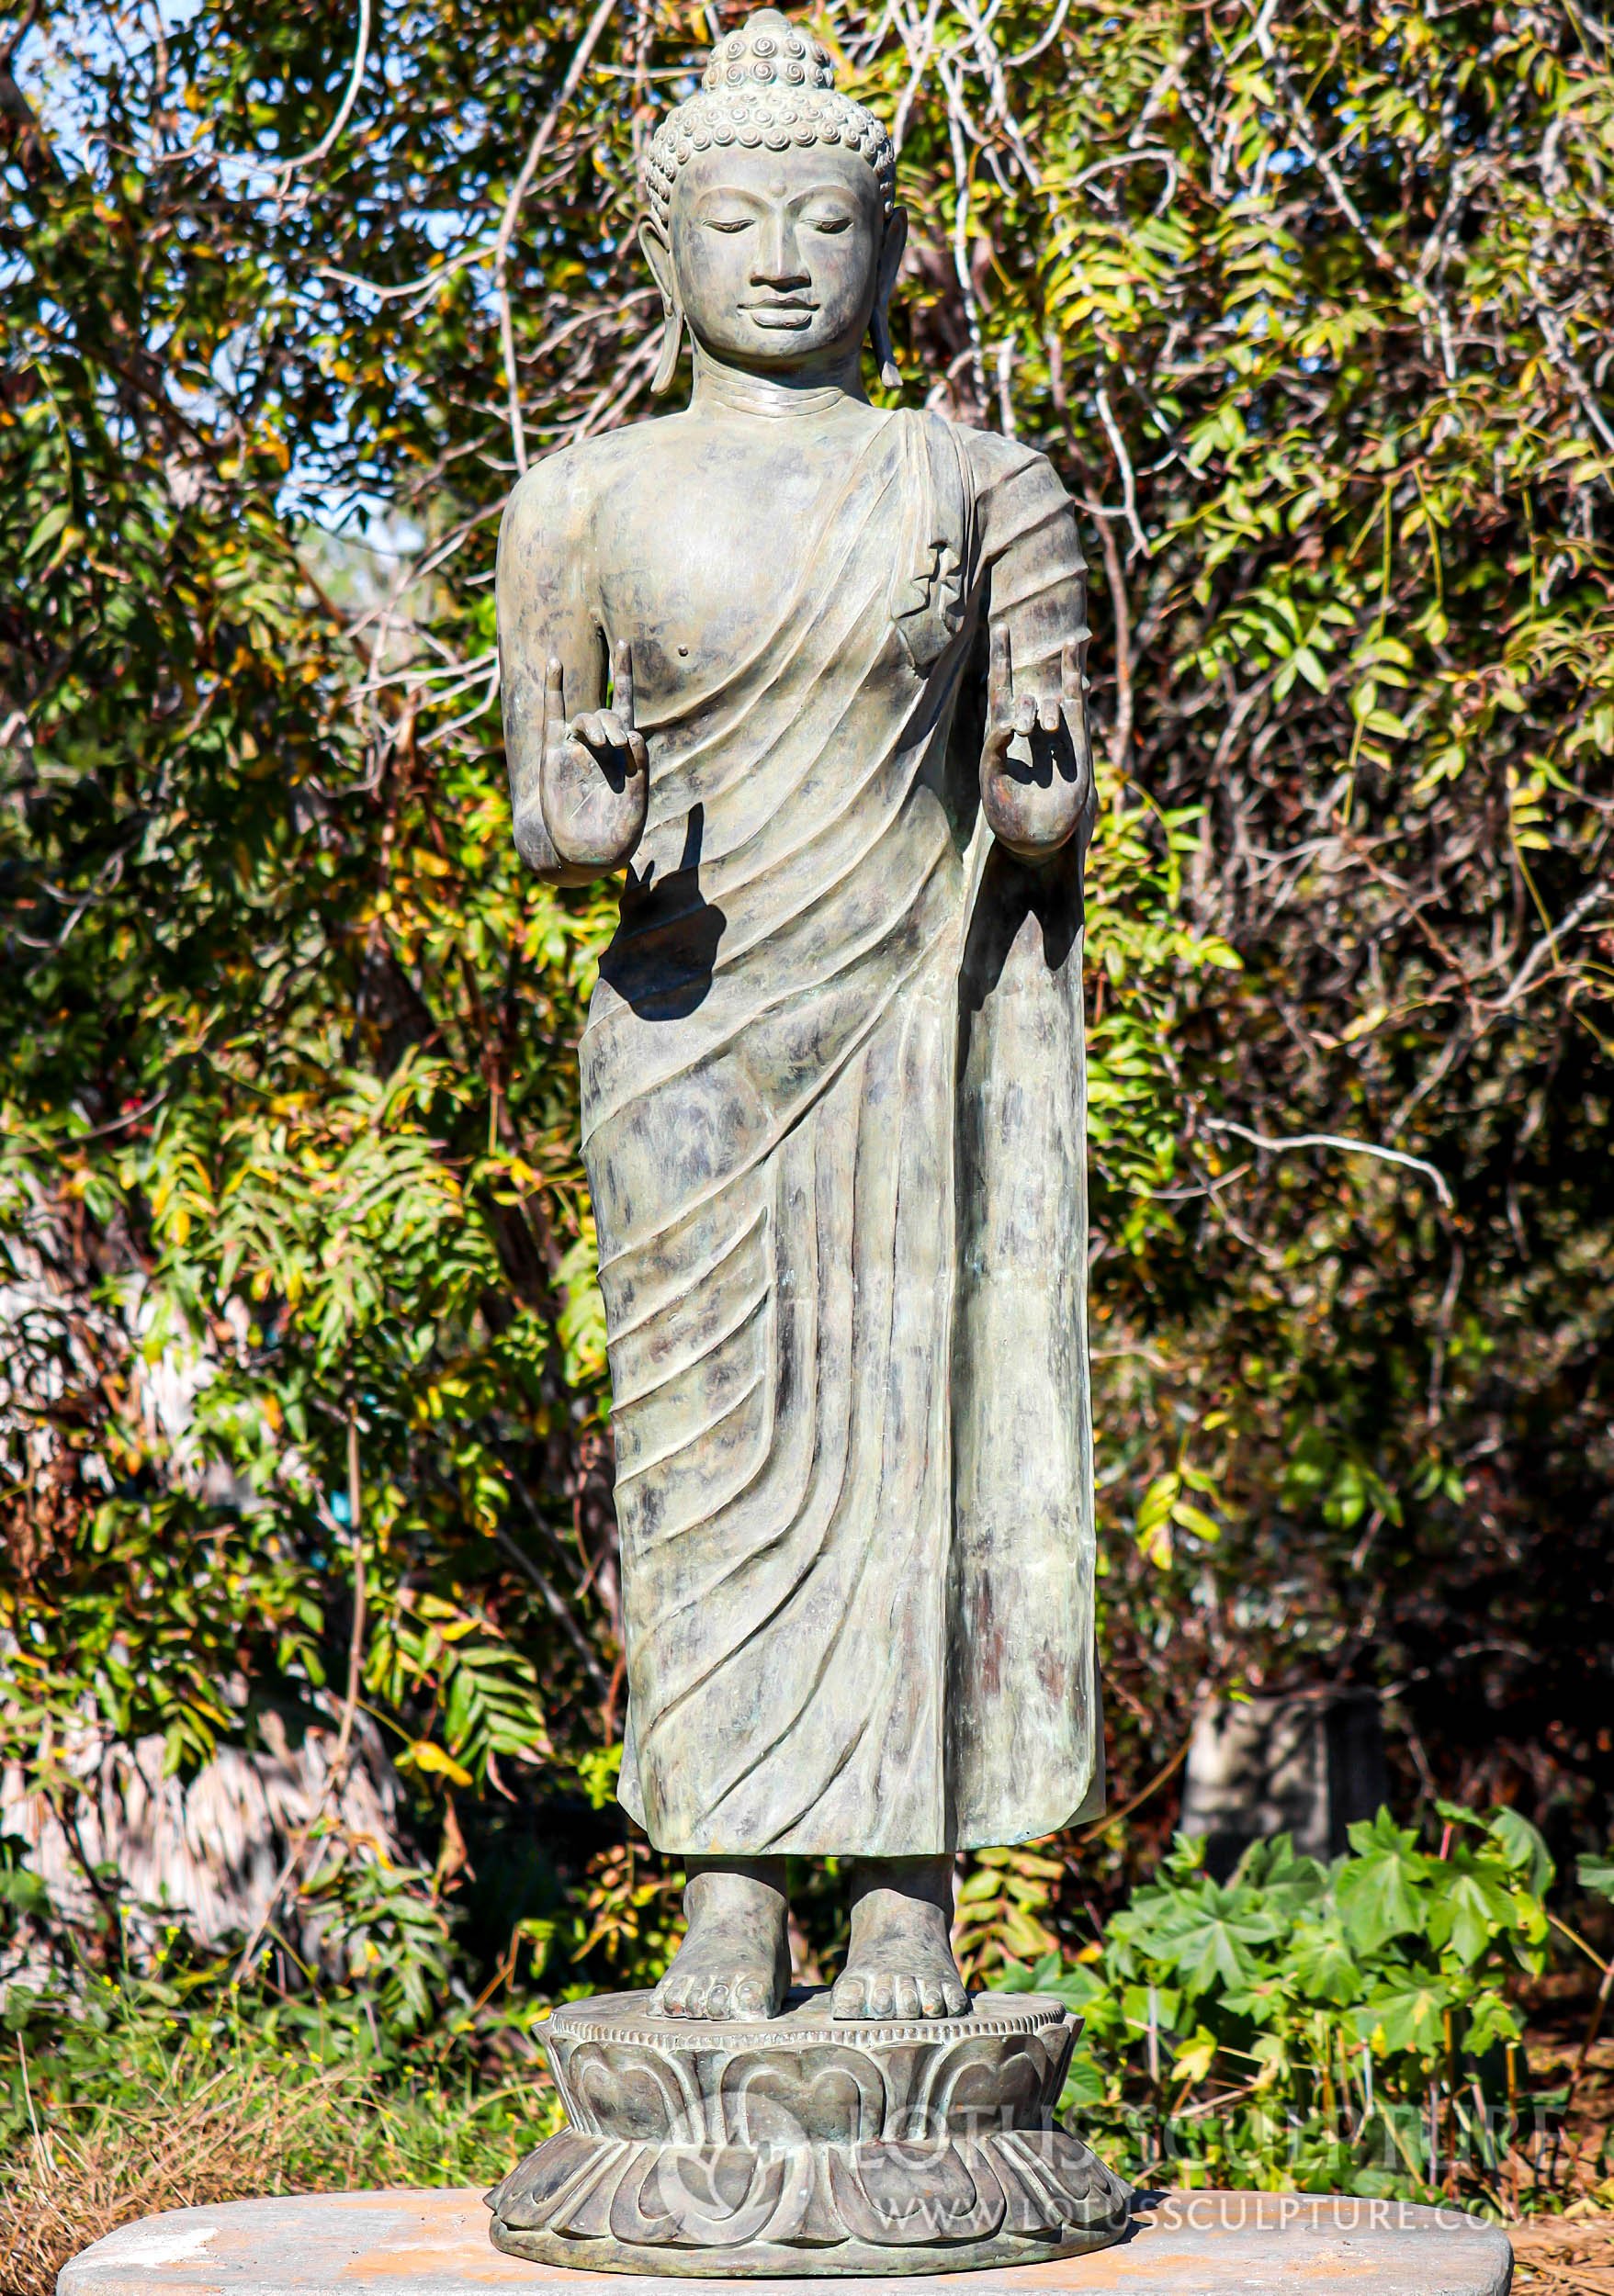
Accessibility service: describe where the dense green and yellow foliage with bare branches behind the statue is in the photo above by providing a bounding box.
[0,0,1614,2103]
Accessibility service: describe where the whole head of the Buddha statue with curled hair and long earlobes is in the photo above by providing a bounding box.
[643,7,907,390]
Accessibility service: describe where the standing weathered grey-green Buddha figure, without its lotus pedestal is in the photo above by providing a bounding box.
[498,9,1102,2020]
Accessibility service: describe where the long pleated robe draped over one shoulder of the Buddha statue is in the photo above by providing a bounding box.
[581,413,1102,1855]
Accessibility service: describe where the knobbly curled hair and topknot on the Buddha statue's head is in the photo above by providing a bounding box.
[643,7,897,232]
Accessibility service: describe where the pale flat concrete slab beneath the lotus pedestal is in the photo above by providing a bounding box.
[57,2190,1513,2296]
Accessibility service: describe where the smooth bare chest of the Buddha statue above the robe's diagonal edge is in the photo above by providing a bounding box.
[594,425,881,703]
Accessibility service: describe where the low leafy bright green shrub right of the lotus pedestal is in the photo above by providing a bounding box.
[999,1805,1597,2209]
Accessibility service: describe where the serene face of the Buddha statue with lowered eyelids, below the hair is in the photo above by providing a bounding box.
[671,145,900,372]
